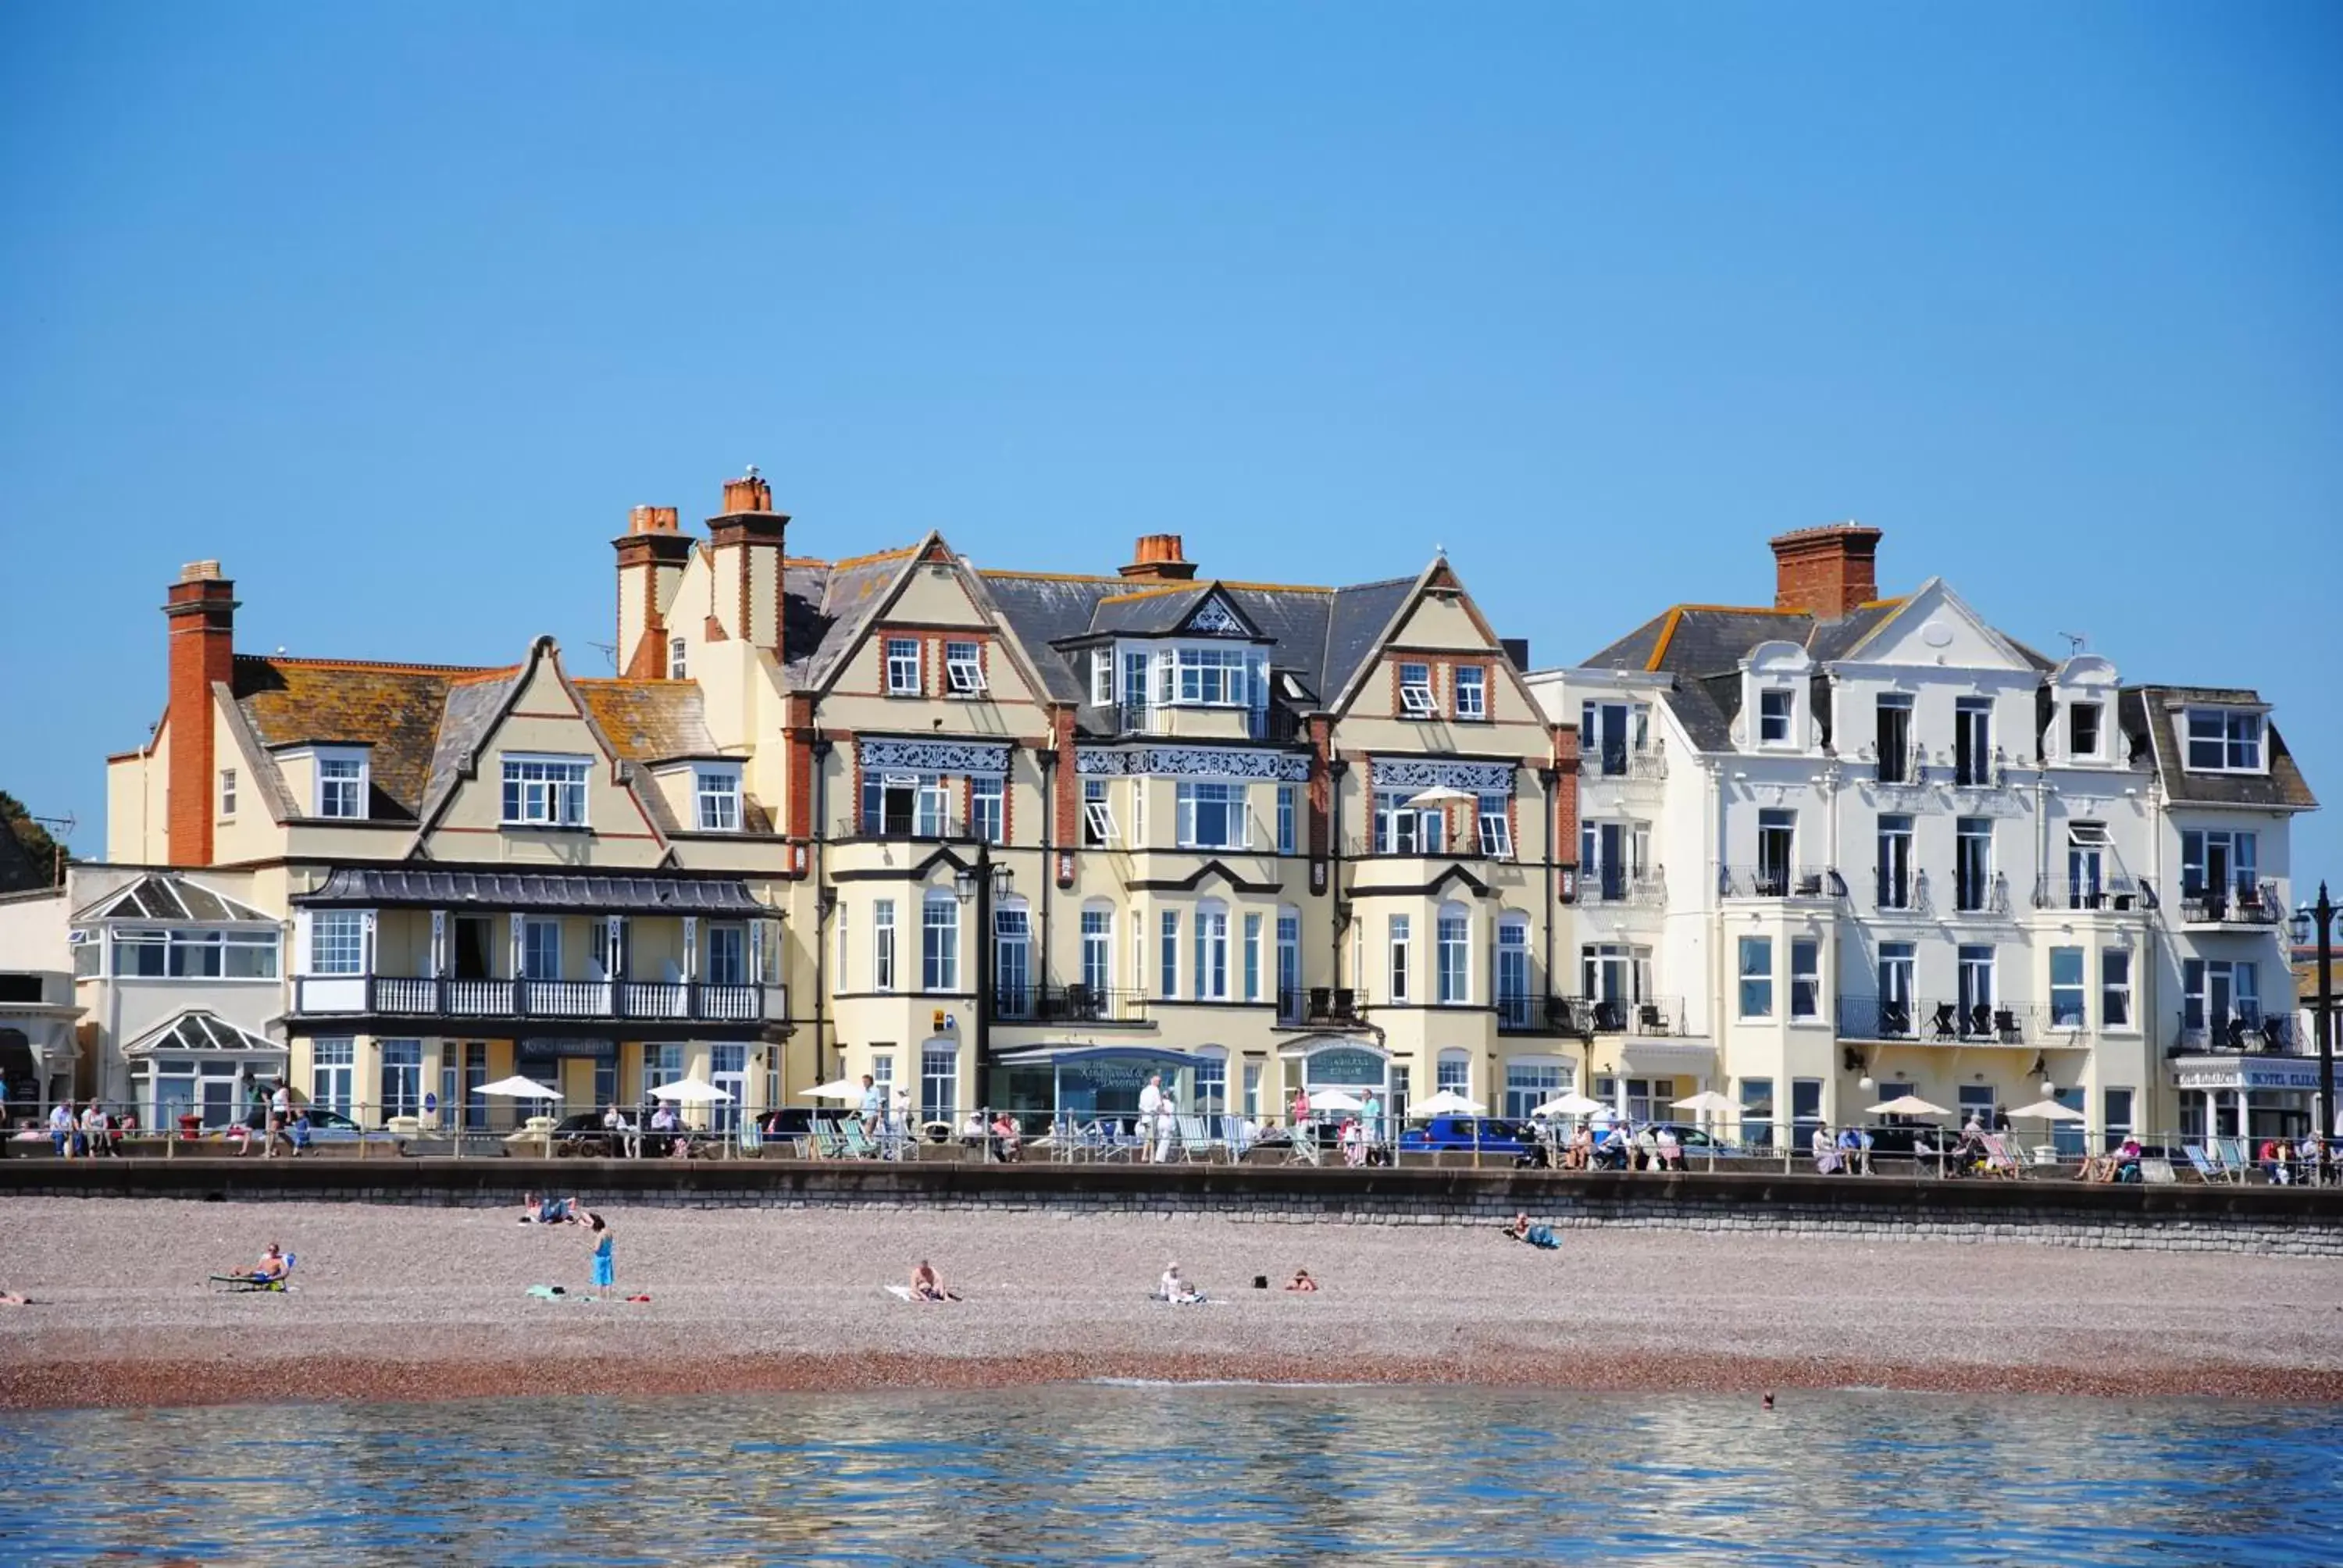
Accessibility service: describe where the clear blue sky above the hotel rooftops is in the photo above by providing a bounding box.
[0,0,2343,875]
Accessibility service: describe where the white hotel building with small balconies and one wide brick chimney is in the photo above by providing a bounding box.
[1530,525,2317,1149]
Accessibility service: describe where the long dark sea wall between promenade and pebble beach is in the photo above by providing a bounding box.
[0,1158,2343,1256]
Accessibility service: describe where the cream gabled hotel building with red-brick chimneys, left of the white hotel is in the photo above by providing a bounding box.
[101,473,1582,1125]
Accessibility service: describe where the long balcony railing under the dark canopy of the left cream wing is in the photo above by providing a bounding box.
[293,975,790,1025]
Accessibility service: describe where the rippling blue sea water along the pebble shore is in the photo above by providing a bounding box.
[0,1385,2343,1568]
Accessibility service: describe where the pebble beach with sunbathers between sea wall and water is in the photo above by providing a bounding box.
[0,1198,2343,1409]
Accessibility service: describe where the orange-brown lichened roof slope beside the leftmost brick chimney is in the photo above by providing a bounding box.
[227,654,499,823]
